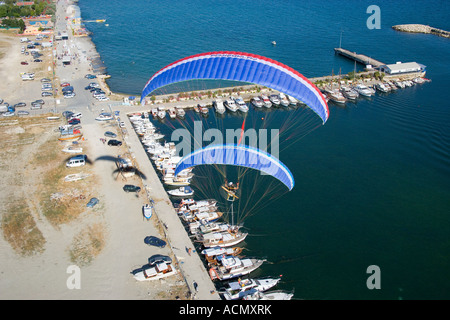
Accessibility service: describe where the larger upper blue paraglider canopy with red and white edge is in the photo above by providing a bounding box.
[141,51,329,123]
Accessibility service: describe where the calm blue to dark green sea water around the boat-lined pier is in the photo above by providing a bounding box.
[79,0,450,299]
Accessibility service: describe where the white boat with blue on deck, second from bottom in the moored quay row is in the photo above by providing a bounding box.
[219,278,281,300]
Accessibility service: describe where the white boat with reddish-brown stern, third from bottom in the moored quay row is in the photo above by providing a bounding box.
[209,256,265,281]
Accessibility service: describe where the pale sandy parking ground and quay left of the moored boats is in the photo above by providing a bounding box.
[0,1,219,300]
